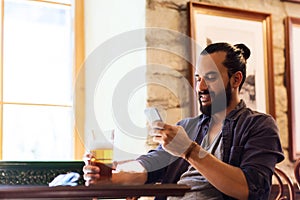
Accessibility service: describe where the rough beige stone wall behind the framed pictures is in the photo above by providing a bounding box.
[146,0,300,181]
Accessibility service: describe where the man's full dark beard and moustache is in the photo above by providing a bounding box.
[198,82,232,116]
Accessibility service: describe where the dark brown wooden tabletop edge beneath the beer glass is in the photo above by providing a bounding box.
[0,184,190,199]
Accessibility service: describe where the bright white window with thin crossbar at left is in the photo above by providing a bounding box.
[0,0,83,161]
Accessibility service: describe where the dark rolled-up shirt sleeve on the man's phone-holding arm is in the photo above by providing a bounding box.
[231,115,284,200]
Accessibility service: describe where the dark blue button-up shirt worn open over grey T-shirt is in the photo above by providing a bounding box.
[137,101,284,200]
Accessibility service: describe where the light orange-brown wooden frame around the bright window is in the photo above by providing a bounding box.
[0,0,85,161]
